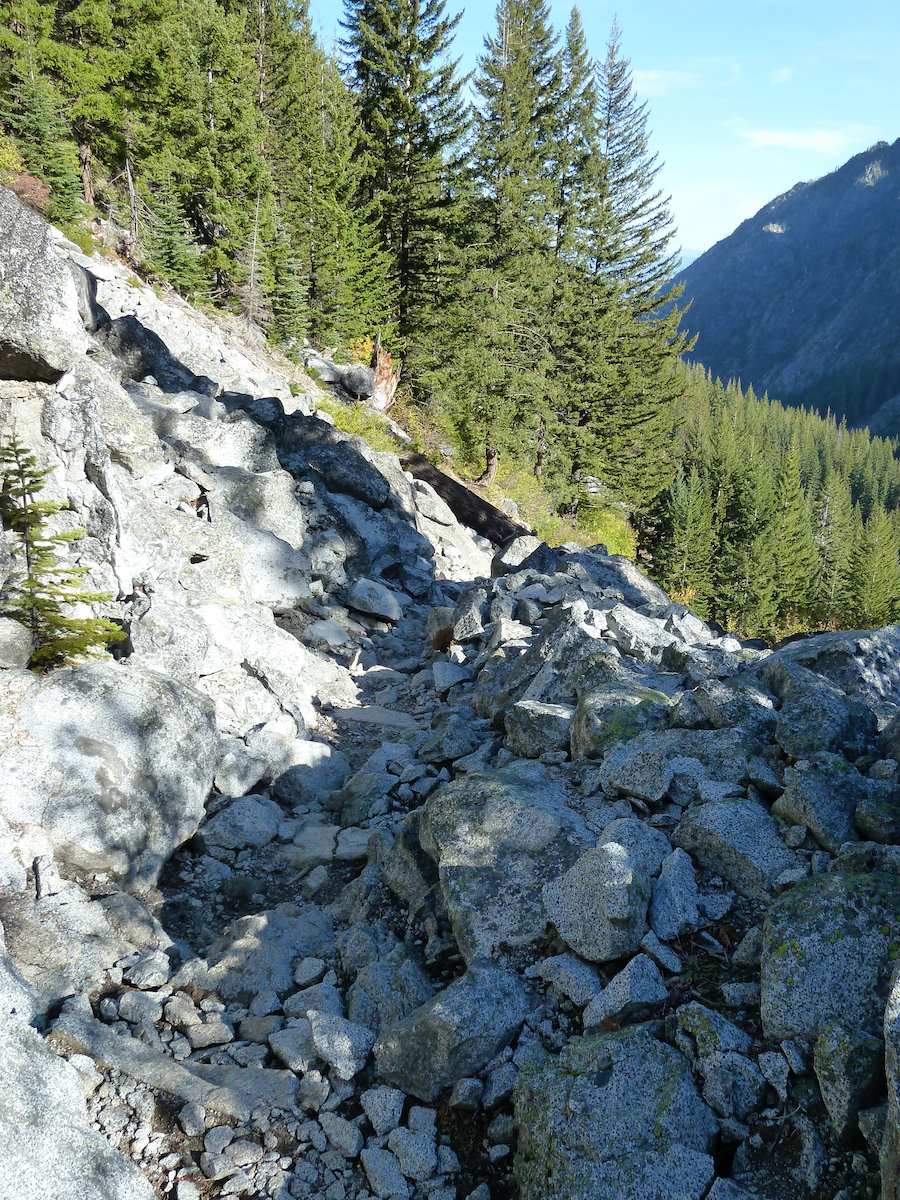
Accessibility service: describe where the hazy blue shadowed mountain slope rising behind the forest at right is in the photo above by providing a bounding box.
[676,139,900,434]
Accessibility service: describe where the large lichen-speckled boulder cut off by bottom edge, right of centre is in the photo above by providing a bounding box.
[515,1028,719,1200]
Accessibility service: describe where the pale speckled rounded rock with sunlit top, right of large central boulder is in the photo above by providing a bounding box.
[542,841,650,962]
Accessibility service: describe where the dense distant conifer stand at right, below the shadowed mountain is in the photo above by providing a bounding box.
[642,367,900,638]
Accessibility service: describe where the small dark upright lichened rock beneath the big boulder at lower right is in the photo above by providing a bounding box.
[814,1021,884,1141]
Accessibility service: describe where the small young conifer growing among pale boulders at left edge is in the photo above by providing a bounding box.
[0,438,125,670]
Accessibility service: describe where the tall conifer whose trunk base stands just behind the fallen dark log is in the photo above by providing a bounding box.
[434,0,558,481]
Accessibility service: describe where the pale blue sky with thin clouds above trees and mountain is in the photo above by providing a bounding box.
[311,0,900,252]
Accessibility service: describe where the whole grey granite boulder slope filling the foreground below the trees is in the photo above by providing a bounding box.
[0,184,900,1200]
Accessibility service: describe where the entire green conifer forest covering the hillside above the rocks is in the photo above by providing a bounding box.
[0,0,900,638]
